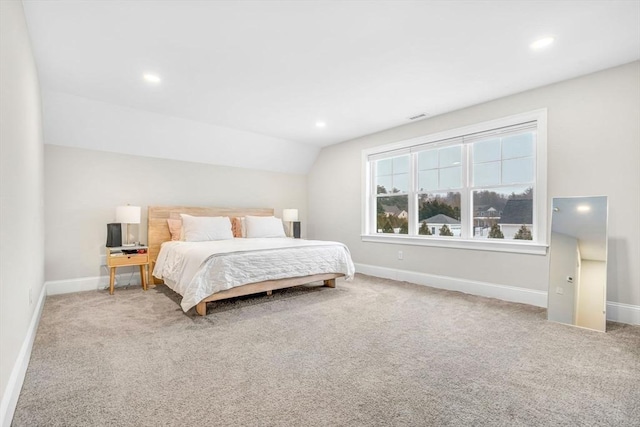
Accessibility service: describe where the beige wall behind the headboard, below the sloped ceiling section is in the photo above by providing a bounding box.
[45,144,307,281]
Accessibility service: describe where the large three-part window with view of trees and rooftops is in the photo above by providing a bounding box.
[363,110,546,253]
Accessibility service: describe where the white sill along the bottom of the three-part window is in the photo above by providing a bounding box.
[361,234,547,255]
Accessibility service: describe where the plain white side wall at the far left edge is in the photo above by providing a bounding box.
[0,1,44,425]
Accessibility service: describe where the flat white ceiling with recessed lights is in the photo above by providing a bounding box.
[23,0,640,146]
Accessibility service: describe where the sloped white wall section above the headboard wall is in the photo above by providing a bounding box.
[43,91,320,174]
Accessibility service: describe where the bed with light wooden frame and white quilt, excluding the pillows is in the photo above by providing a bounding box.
[148,206,354,316]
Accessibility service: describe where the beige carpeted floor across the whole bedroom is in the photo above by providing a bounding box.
[12,275,640,427]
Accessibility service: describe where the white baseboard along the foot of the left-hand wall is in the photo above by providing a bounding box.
[0,285,47,426]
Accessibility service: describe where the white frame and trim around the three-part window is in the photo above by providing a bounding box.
[361,108,548,255]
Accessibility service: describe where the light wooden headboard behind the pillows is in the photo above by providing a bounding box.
[147,206,273,268]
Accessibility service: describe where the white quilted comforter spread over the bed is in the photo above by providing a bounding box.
[153,238,355,312]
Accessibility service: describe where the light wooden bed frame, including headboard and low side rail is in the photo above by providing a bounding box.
[147,206,344,316]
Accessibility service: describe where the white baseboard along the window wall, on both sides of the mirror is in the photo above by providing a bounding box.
[356,264,640,325]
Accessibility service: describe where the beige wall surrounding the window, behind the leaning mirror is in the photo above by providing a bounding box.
[308,62,640,305]
